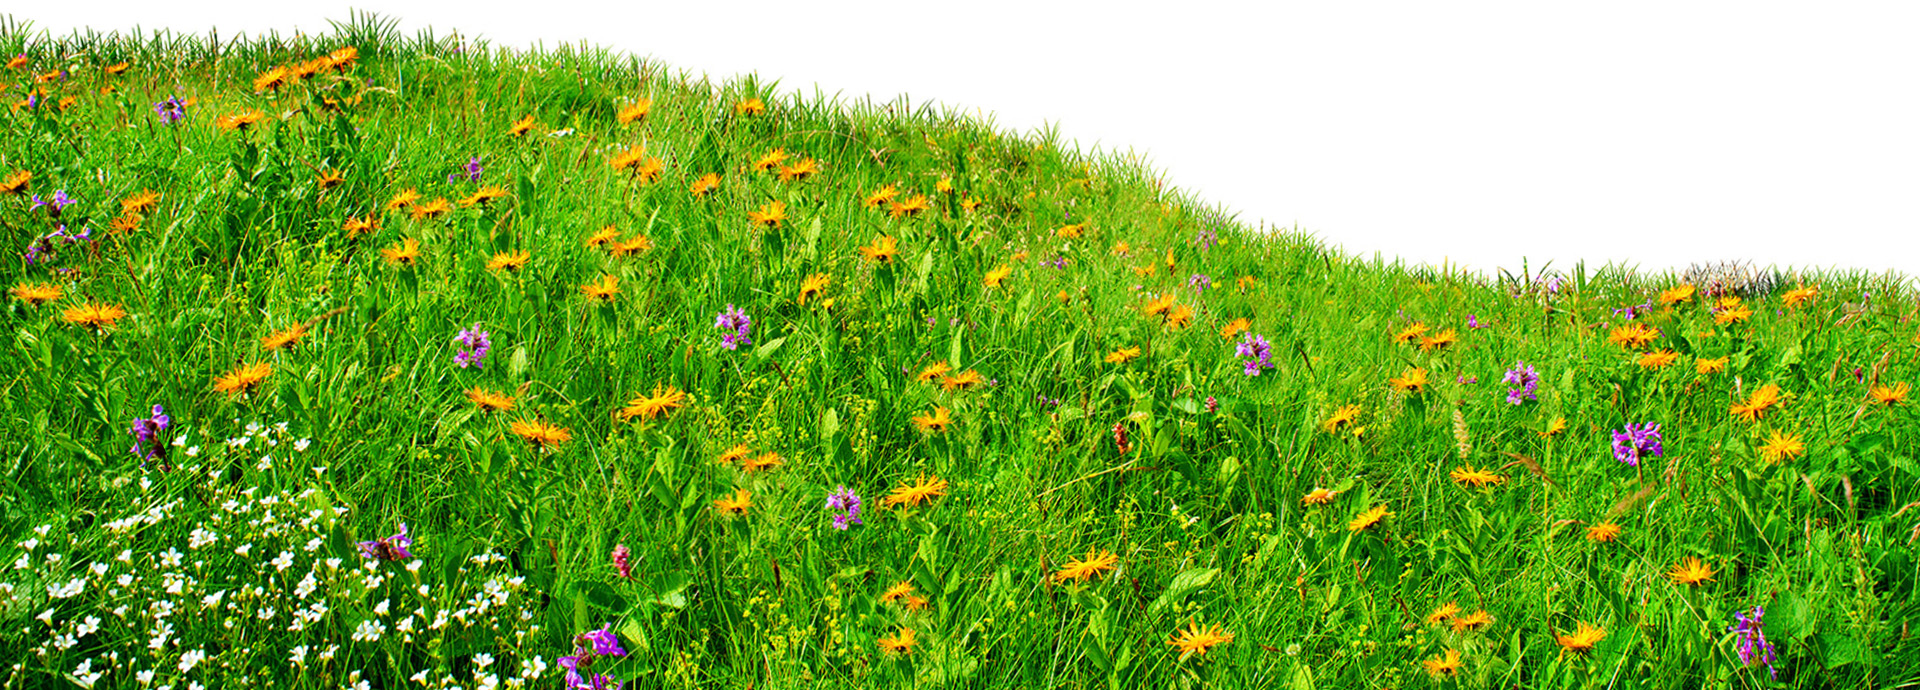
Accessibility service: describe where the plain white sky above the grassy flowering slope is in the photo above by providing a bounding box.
[13,0,1920,286]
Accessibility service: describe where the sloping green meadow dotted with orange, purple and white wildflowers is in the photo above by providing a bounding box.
[0,15,1920,690]
